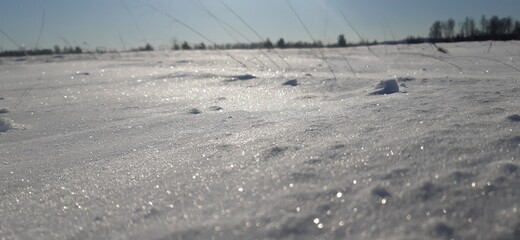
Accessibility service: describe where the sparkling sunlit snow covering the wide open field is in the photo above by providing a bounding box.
[0,42,520,239]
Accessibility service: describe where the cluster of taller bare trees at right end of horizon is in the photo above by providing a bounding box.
[429,15,520,42]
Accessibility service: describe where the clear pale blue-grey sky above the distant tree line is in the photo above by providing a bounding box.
[0,0,520,50]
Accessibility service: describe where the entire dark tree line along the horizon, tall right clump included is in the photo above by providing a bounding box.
[0,15,520,57]
